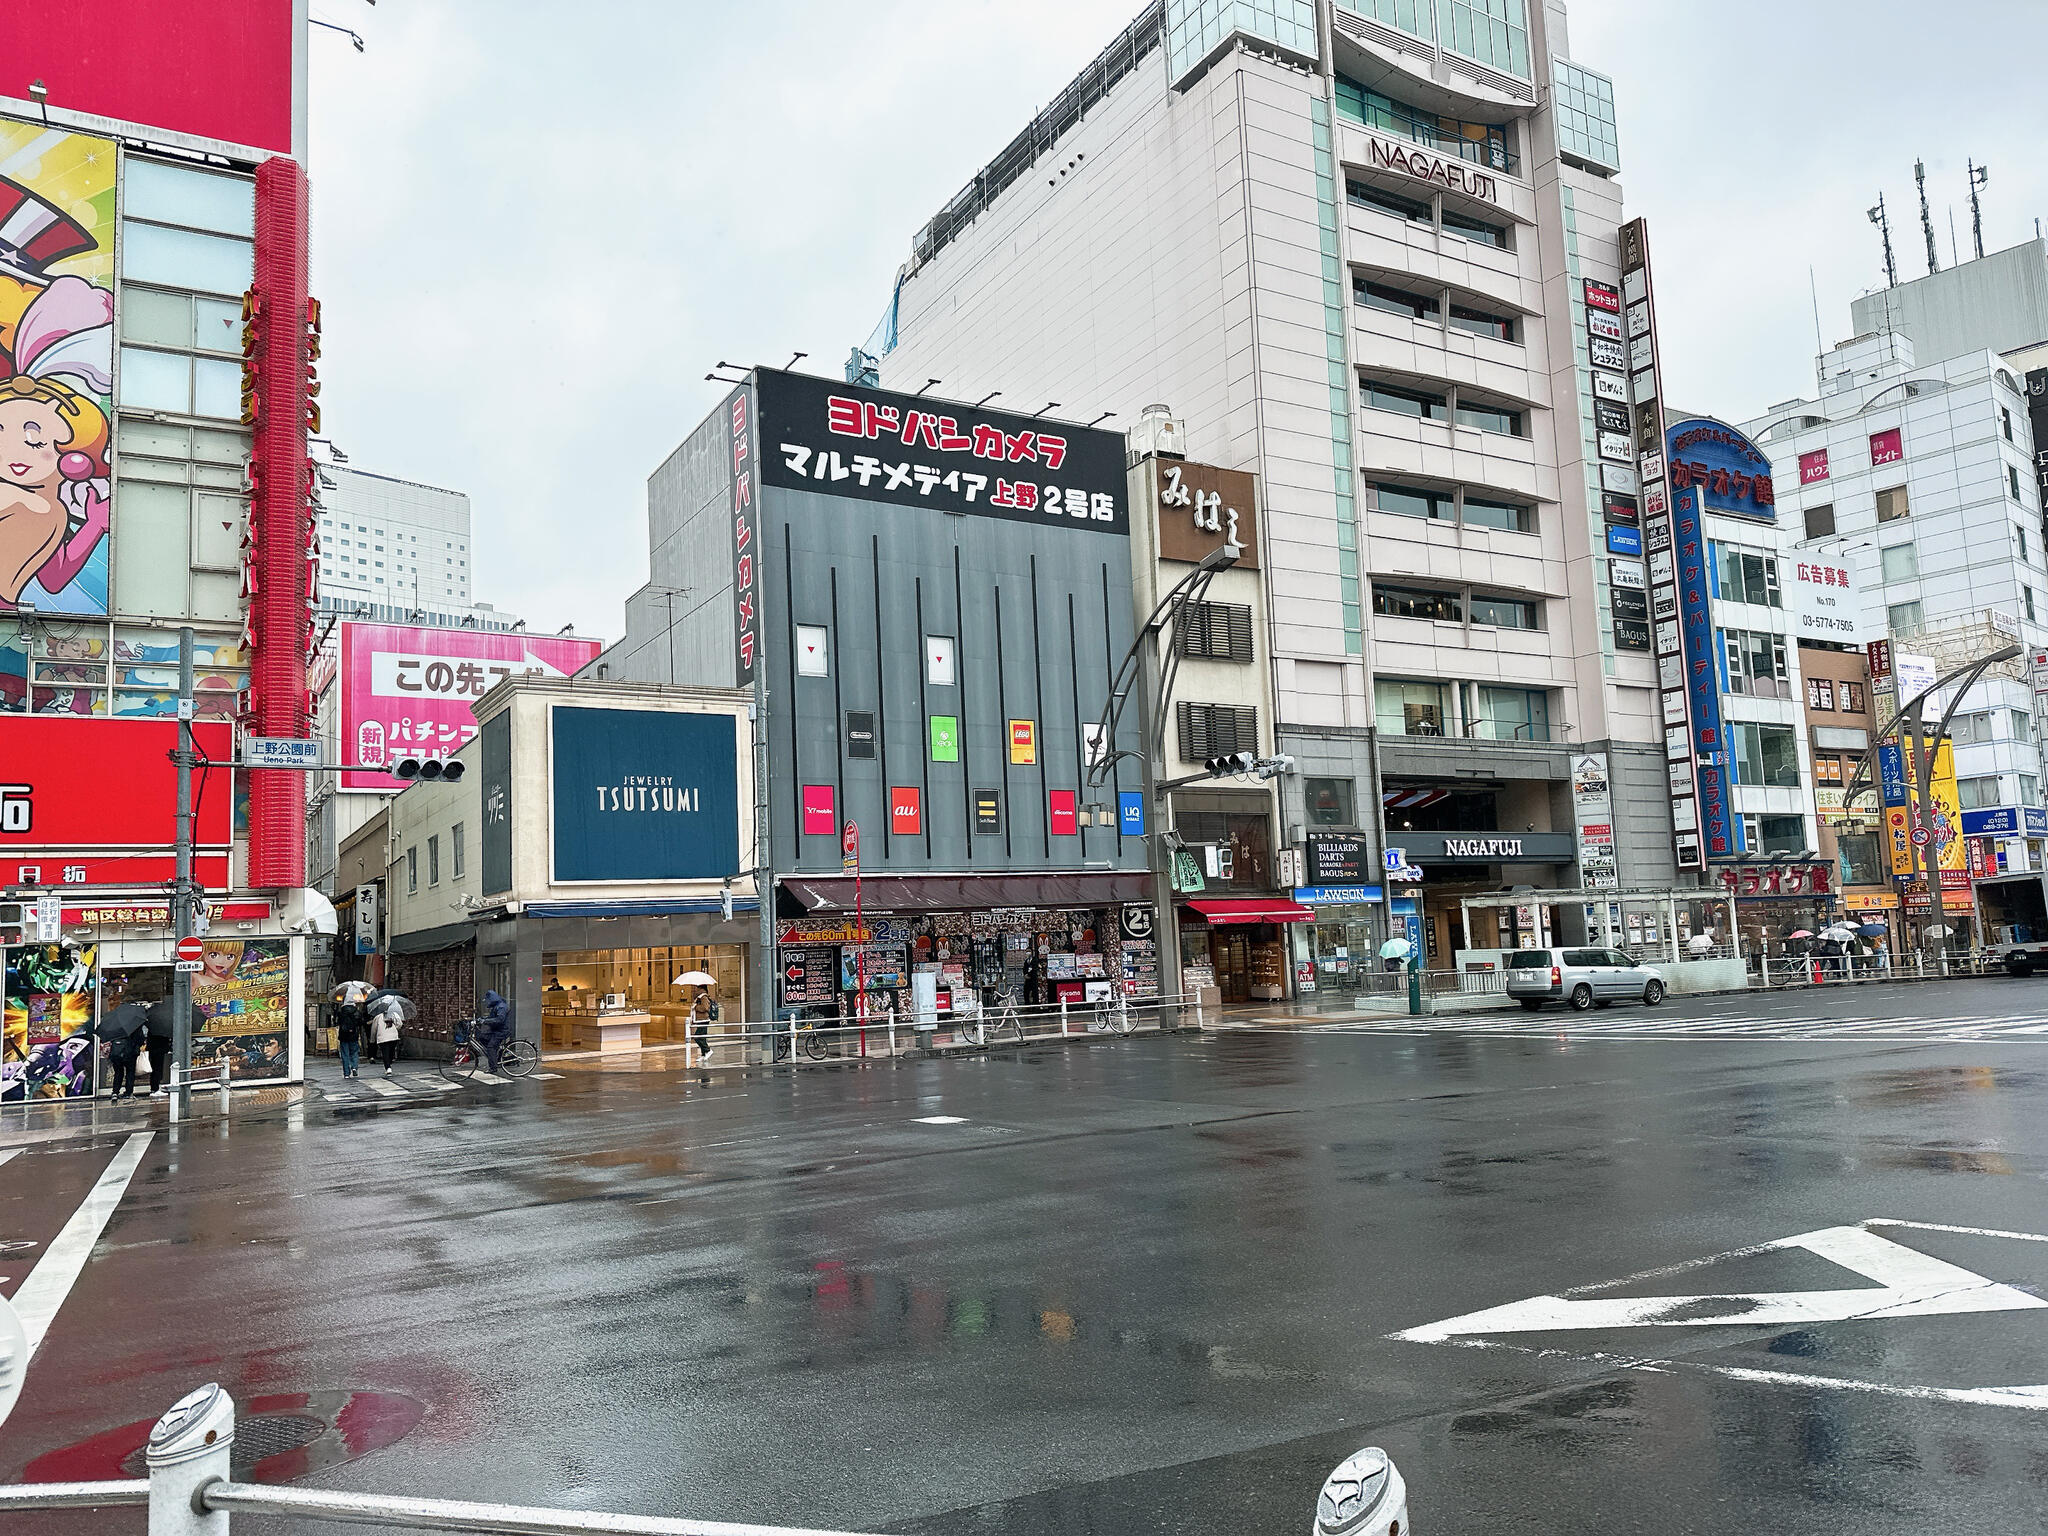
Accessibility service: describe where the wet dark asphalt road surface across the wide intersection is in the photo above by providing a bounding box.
[0,979,2048,1536]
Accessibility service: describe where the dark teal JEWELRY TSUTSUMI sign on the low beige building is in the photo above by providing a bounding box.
[549,705,739,885]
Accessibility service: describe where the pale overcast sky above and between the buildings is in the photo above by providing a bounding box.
[311,0,2048,637]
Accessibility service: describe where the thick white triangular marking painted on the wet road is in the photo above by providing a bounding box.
[1393,1227,2048,1343]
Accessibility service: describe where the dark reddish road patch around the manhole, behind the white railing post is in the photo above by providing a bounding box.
[23,1393,426,1483]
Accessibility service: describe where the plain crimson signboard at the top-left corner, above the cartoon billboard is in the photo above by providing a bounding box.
[0,0,303,154]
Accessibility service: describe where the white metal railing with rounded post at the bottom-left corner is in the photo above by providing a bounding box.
[0,1386,892,1536]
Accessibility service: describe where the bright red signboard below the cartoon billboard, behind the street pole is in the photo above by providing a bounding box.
[0,715,231,856]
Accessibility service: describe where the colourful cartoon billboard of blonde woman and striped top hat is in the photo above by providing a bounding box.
[0,121,115,614]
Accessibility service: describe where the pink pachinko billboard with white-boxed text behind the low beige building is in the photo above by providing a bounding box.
[338,625,604,791]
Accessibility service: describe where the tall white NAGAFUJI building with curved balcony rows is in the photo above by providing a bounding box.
[850,0,1692,971]
